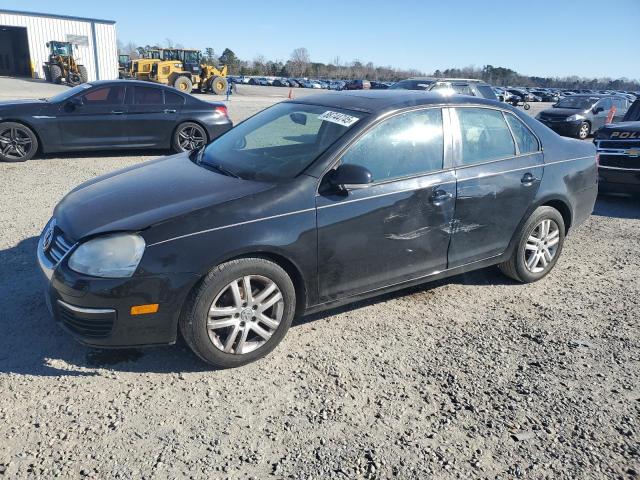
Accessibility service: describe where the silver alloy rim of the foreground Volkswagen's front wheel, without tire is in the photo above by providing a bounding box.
[207,275,284,355]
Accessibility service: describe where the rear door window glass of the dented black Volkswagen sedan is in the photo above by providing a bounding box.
[456,108,516,166]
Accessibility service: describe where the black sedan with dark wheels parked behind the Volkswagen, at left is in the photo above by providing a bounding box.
[0,80,232,162]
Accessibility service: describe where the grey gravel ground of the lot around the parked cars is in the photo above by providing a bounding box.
[0,79,640,479]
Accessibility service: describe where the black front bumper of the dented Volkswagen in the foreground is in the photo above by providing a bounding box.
[37,227,197,347]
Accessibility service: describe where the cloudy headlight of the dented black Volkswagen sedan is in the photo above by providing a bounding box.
[69,233,145,278]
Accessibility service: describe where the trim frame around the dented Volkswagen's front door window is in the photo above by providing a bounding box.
[316,105,455,195]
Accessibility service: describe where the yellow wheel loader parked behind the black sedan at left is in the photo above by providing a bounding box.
[149,49,228,95]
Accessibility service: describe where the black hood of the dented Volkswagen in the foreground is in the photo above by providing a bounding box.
[53,153,271,240]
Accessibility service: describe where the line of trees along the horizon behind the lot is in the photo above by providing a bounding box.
[118,39,640,91]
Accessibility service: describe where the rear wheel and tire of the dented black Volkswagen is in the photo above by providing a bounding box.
[498,207,565,283]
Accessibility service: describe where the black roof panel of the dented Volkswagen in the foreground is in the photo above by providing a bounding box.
[288,90,504,113]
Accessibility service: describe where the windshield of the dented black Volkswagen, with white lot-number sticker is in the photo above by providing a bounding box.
[195,102,365,182]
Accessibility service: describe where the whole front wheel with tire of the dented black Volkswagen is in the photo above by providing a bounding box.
[180,258,296,368]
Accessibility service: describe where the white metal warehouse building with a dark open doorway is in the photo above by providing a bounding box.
[0,9,118,80]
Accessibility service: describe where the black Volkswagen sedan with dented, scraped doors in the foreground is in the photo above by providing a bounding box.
[37,90,597,367]
